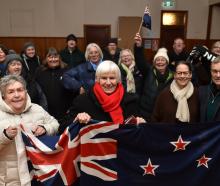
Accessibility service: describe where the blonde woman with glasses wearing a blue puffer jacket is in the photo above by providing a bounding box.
[62,43,103,94]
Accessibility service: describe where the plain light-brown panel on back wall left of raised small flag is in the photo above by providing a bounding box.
[118,17,142,50]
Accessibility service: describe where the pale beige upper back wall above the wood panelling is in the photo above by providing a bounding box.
[0,0,220,39]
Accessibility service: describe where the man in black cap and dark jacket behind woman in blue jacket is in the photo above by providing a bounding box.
[60,34,85,68]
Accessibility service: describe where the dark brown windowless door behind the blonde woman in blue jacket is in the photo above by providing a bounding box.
[84,25,111,48]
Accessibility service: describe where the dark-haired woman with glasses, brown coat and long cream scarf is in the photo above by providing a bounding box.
[152,61,199,123]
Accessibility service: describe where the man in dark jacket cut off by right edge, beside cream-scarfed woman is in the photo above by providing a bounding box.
[199,56,220,122]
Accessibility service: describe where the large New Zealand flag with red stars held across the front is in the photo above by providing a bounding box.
[21,122,220,186]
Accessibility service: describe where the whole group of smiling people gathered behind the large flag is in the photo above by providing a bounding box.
[0,33,220,185]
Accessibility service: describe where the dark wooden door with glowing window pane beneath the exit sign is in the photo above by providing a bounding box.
[160,11,187,50]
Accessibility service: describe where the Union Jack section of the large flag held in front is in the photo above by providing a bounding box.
[21,122,118,185]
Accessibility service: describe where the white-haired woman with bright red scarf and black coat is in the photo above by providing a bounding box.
[61,61,145,130]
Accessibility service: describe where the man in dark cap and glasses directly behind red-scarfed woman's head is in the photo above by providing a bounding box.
[103,39,121,64]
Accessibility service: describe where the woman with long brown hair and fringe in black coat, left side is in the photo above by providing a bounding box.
[36,48,74,120]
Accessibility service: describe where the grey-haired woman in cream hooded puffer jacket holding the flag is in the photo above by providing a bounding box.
[0,75,59,186]
